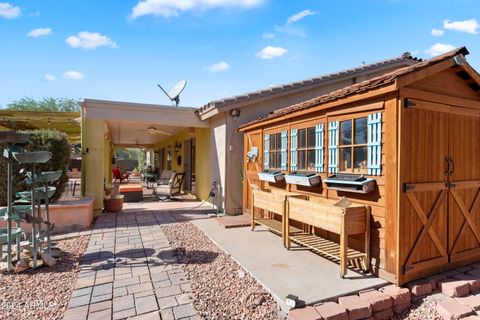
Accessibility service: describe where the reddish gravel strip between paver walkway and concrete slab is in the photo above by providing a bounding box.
[162,222,281,319]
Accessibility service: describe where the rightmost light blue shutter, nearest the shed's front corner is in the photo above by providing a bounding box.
[367,112,382,176]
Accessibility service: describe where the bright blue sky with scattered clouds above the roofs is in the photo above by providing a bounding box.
[0,0,480,107]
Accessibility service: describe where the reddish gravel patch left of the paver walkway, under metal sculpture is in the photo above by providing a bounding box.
[0,237,89,320]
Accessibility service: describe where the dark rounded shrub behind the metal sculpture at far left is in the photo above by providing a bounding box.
[0,130,71,206]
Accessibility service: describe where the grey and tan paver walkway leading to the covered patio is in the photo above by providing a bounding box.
[64,202,212,320]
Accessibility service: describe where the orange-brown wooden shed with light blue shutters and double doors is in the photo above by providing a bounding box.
[239,48,480,284]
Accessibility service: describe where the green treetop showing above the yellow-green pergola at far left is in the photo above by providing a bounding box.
[6,98,80,112]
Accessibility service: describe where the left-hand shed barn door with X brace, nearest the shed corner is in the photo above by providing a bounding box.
[399,108,449,283]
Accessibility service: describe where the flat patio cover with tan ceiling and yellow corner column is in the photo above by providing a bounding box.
[81,99,209,215]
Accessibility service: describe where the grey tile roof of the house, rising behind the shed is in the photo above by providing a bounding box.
[197,52,421,115]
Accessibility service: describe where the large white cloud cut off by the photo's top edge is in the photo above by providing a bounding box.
[130,0,265,19]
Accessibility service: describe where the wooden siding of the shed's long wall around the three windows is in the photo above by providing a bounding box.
[243,95,397,278]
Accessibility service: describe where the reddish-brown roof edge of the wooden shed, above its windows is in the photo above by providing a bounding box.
[239,47,469,129]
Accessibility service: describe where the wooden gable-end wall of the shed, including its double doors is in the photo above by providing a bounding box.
[397,67,480,283]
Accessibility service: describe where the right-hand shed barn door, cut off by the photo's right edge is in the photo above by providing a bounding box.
[448,114,480,263]
